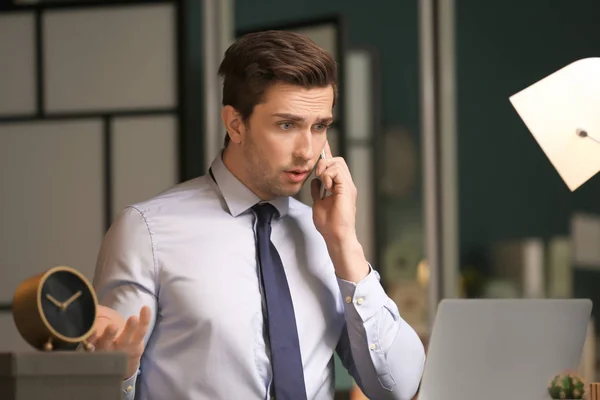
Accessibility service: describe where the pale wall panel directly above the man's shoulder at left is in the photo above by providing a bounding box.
[111,115,178,217]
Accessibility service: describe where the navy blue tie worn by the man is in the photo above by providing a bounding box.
[252,203,306,400]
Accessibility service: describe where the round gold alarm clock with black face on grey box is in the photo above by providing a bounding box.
[12,266,98,351]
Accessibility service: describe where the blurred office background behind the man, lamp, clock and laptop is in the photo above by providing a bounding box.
[0,0,600,399]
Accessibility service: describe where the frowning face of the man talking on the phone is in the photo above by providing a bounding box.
[241,84,334,199]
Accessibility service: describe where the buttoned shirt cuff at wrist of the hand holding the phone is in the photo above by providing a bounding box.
[337,264,388,322]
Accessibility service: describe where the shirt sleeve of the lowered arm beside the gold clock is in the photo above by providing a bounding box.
[94,207,158,400]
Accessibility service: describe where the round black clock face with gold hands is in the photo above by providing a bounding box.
[40,270,96,339]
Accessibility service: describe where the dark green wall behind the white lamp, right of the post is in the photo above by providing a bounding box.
[456,0,600,266]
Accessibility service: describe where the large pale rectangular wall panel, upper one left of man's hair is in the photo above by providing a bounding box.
[43,4,177,112]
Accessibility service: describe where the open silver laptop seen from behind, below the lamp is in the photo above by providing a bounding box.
[418,299,592,400]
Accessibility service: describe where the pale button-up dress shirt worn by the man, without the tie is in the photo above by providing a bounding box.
[94,152,425,400]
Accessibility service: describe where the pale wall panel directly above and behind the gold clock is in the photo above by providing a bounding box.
[0,121,105,302]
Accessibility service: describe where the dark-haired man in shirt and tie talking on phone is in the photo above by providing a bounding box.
[92,31,425,400]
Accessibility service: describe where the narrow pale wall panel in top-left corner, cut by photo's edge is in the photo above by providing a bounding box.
[0,13,36,116]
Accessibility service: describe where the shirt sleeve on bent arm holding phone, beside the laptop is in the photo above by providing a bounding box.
[337,268,425,400]
